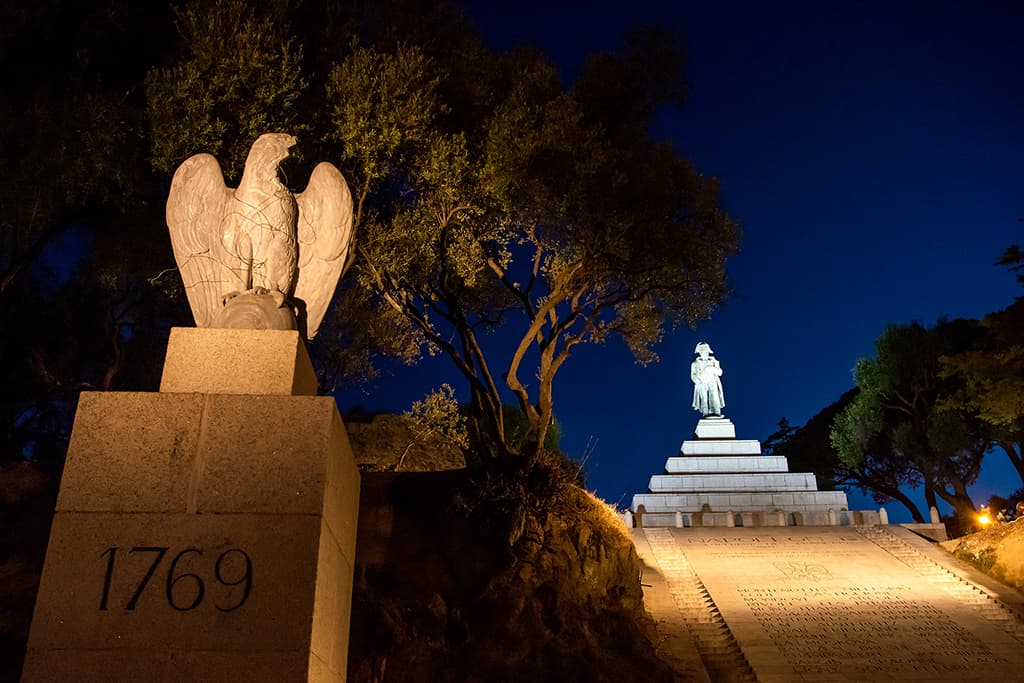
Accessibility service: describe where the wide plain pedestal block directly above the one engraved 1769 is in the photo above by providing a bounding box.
[57,392,358,528]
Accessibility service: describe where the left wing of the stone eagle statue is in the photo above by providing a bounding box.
[167,154,240,328]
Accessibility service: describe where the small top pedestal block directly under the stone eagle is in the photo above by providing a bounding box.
[160,328,316,396]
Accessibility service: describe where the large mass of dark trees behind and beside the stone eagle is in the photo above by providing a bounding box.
[0,0,739,466]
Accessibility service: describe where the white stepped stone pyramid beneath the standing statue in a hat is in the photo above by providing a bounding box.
[632,417,847,527]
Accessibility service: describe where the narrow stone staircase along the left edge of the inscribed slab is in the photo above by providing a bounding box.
[644,528,757,683]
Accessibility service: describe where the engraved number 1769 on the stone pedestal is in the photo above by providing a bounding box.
[99,546,253,612]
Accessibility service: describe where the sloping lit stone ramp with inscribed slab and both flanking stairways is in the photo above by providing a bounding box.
[632,525,1024,683]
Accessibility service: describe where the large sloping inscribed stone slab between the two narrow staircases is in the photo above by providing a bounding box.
[638,527,1024,683]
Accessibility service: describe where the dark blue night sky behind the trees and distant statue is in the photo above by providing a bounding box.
[341,0,1024,521]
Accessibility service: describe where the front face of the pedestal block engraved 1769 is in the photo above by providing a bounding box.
[29,512,321,661]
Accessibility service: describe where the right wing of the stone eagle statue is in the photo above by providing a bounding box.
[295,162,352,339]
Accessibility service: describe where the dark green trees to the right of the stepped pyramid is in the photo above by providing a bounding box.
[768,246,1024,528]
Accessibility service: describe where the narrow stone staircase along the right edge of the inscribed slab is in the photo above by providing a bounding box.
[854,525,1024,644]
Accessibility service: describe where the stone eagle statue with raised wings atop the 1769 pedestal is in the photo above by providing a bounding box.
[167,133,353,339]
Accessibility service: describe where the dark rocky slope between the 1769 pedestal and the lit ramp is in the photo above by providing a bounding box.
[349,462,674,682]
